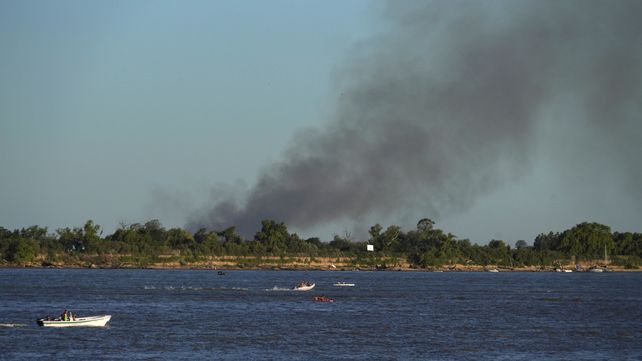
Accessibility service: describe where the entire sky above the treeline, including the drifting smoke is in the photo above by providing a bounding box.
[0,0,642,243]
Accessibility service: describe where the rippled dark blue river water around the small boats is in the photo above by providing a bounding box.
[0,269,642,360]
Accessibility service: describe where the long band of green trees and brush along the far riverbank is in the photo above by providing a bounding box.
[0,218,642,268]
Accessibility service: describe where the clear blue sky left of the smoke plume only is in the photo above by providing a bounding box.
[0,0,371,233]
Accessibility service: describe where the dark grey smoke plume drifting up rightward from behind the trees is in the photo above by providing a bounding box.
[189,0,642,235]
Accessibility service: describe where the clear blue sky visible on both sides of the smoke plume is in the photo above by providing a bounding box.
[0,0,642,243]
